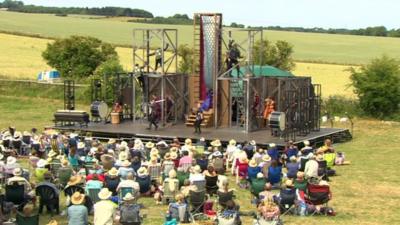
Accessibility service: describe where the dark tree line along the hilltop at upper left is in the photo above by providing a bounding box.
[0,0,153,18]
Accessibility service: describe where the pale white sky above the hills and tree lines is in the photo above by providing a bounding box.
[23,0,400,29]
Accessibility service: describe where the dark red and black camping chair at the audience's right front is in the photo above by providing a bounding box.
[305,183,332,206]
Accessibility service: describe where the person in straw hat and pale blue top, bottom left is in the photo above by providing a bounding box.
[67,192,89,225]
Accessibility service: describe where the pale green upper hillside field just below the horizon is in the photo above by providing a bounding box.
[0,11,400,64]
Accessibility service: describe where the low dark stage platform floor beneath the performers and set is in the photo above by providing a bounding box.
[51,121,351,147]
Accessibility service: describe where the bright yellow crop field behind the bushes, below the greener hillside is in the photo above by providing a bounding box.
[0,34,352,97]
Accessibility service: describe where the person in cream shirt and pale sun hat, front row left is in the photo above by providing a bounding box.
[93,188,118,225]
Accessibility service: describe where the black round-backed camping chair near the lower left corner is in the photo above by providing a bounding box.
[36,185,60,216]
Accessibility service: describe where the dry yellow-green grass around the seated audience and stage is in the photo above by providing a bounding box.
[0,96,400,225]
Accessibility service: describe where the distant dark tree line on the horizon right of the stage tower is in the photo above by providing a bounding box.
[249,26,400,37]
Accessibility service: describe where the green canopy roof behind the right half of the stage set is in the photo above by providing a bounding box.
[232,65,294,77]
